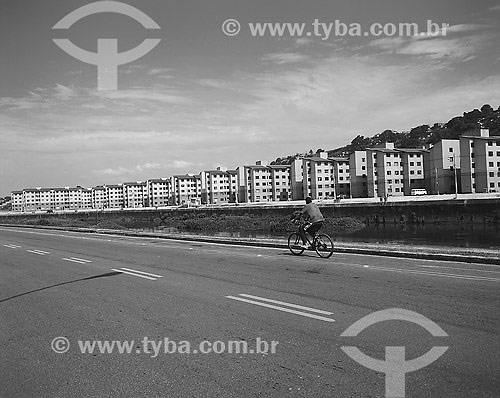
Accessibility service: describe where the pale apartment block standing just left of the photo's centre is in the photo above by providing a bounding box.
[200,167,238,204]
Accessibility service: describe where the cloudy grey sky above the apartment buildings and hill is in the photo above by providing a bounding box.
[0,0,500,196]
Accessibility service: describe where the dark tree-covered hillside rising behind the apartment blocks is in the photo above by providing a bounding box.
[271,104,500,164]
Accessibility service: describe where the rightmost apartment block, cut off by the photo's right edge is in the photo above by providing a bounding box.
[460,129,500,193]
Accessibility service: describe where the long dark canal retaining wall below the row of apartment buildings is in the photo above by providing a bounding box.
[0,199,500,227]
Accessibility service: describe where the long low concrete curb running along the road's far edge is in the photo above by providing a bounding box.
[0,224,500,265]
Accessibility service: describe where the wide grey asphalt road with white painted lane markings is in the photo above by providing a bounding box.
[0,228,500,398]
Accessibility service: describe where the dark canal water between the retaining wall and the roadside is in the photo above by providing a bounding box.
[149,223,500,250]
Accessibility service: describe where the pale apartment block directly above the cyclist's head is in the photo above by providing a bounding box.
[302,152,336,199]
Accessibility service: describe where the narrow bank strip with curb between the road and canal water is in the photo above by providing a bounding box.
[0,224,500,265]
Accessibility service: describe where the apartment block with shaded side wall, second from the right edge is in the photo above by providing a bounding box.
[424,140,461,195]
